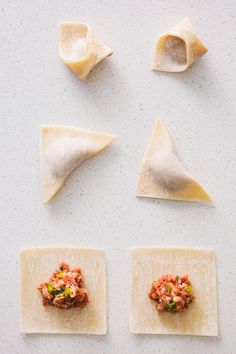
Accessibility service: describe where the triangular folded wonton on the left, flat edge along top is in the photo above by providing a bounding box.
[40,126,115,203]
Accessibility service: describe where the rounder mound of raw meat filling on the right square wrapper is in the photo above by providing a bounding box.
[148,274,195,313]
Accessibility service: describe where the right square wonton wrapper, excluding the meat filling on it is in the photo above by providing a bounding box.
[130,248,218,336]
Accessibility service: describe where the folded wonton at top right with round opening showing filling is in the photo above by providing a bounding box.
[152,18,208,72]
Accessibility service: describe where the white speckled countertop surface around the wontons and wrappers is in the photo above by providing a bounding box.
[0,0,236,354]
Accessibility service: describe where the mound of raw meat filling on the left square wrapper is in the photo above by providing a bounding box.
[38,263,89,309]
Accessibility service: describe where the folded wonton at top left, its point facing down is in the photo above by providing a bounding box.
[60,22,112,80]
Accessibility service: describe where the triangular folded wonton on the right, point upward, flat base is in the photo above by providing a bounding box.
[136,121,211,202]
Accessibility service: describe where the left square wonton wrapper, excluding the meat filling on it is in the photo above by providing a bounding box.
[20,247,107,334]
